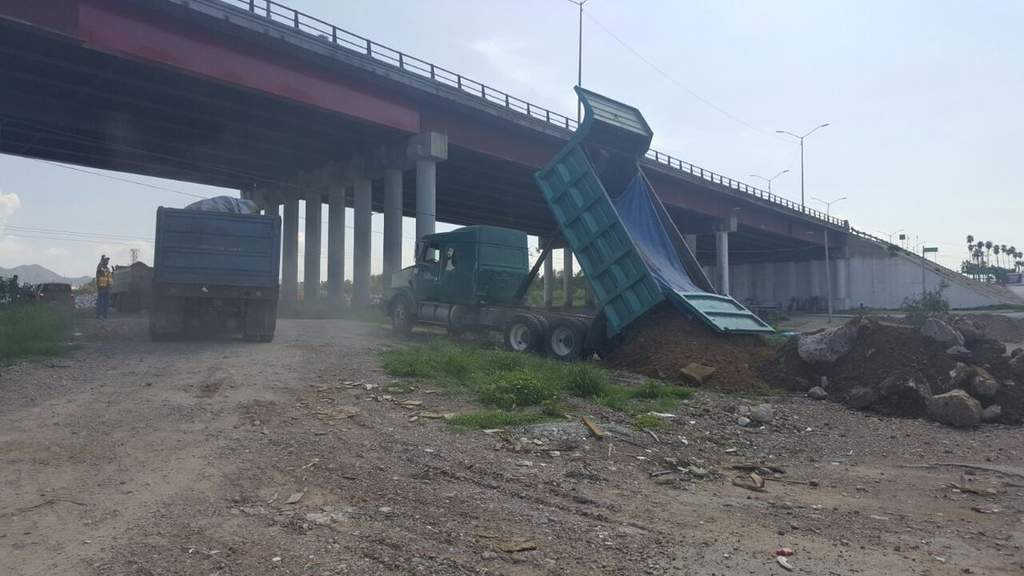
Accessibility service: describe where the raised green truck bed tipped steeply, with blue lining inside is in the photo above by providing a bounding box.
[536,87,773,336]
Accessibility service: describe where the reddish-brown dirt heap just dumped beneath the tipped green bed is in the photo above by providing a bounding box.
[606,303,774,392]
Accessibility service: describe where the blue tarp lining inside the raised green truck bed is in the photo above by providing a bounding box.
[611,174,703,293]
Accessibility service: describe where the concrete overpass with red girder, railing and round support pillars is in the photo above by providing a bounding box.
[0,0,1019,308]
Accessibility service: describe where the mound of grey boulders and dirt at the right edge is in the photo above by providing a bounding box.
[762,317,1024,427]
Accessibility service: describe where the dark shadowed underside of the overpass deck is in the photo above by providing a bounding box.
[0,15,818,262]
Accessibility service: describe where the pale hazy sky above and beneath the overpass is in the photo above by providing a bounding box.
[0,0,1024,277]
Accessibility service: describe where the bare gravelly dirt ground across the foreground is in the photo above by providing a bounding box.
[0,319,1024,576]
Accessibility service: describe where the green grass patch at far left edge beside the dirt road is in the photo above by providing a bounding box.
[0,304,69,361]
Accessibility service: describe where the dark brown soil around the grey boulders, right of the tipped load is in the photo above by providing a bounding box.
[760,319,1024,424]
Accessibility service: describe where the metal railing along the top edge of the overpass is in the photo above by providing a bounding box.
[221,0,850,230]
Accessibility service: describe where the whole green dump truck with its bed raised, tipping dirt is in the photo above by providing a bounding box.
[387,87,772,360]
